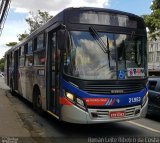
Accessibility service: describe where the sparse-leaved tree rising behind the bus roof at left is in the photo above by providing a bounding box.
[26,10,52,33]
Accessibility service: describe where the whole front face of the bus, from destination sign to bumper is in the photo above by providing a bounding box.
[60,11,148,123]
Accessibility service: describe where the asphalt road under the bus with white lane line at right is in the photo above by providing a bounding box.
[0,79,160,143]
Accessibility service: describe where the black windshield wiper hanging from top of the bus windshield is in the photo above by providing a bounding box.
[89,26,110,67]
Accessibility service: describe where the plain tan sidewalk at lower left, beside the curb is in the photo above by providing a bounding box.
[0,79,30,137]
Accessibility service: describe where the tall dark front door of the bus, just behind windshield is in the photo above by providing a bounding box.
[46,31,59,116]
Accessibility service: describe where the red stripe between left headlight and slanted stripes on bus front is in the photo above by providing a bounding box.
[84,98,109,106]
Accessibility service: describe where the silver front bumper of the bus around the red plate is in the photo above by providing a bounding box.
[61,99,148,124]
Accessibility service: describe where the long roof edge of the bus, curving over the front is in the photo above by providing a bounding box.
[5,7,142,55]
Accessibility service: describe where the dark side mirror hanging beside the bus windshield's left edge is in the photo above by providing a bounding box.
[57,29,68,50]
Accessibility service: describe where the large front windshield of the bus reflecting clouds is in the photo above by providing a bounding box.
[65,31,146,80]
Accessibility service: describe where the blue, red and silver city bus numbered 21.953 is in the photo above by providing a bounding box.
[5,7,148,124]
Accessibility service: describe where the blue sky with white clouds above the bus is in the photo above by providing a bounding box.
[0,0,152,58]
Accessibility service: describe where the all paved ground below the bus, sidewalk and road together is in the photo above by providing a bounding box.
[0,77,160,143]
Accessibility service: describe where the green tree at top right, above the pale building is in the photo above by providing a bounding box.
[143,0,160,40]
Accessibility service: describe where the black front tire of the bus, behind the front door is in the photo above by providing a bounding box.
[33,88,44,115]
